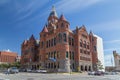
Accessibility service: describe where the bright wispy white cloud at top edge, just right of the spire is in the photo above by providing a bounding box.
[55,0,103,13]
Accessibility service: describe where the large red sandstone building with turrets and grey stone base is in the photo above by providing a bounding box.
[21,7,98,72]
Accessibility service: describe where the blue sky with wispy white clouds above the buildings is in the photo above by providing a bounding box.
[0,0,120,66]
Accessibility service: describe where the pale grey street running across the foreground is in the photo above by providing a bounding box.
[0,73,120,80]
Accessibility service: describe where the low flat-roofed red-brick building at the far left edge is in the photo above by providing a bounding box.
[0,51,17,63]
